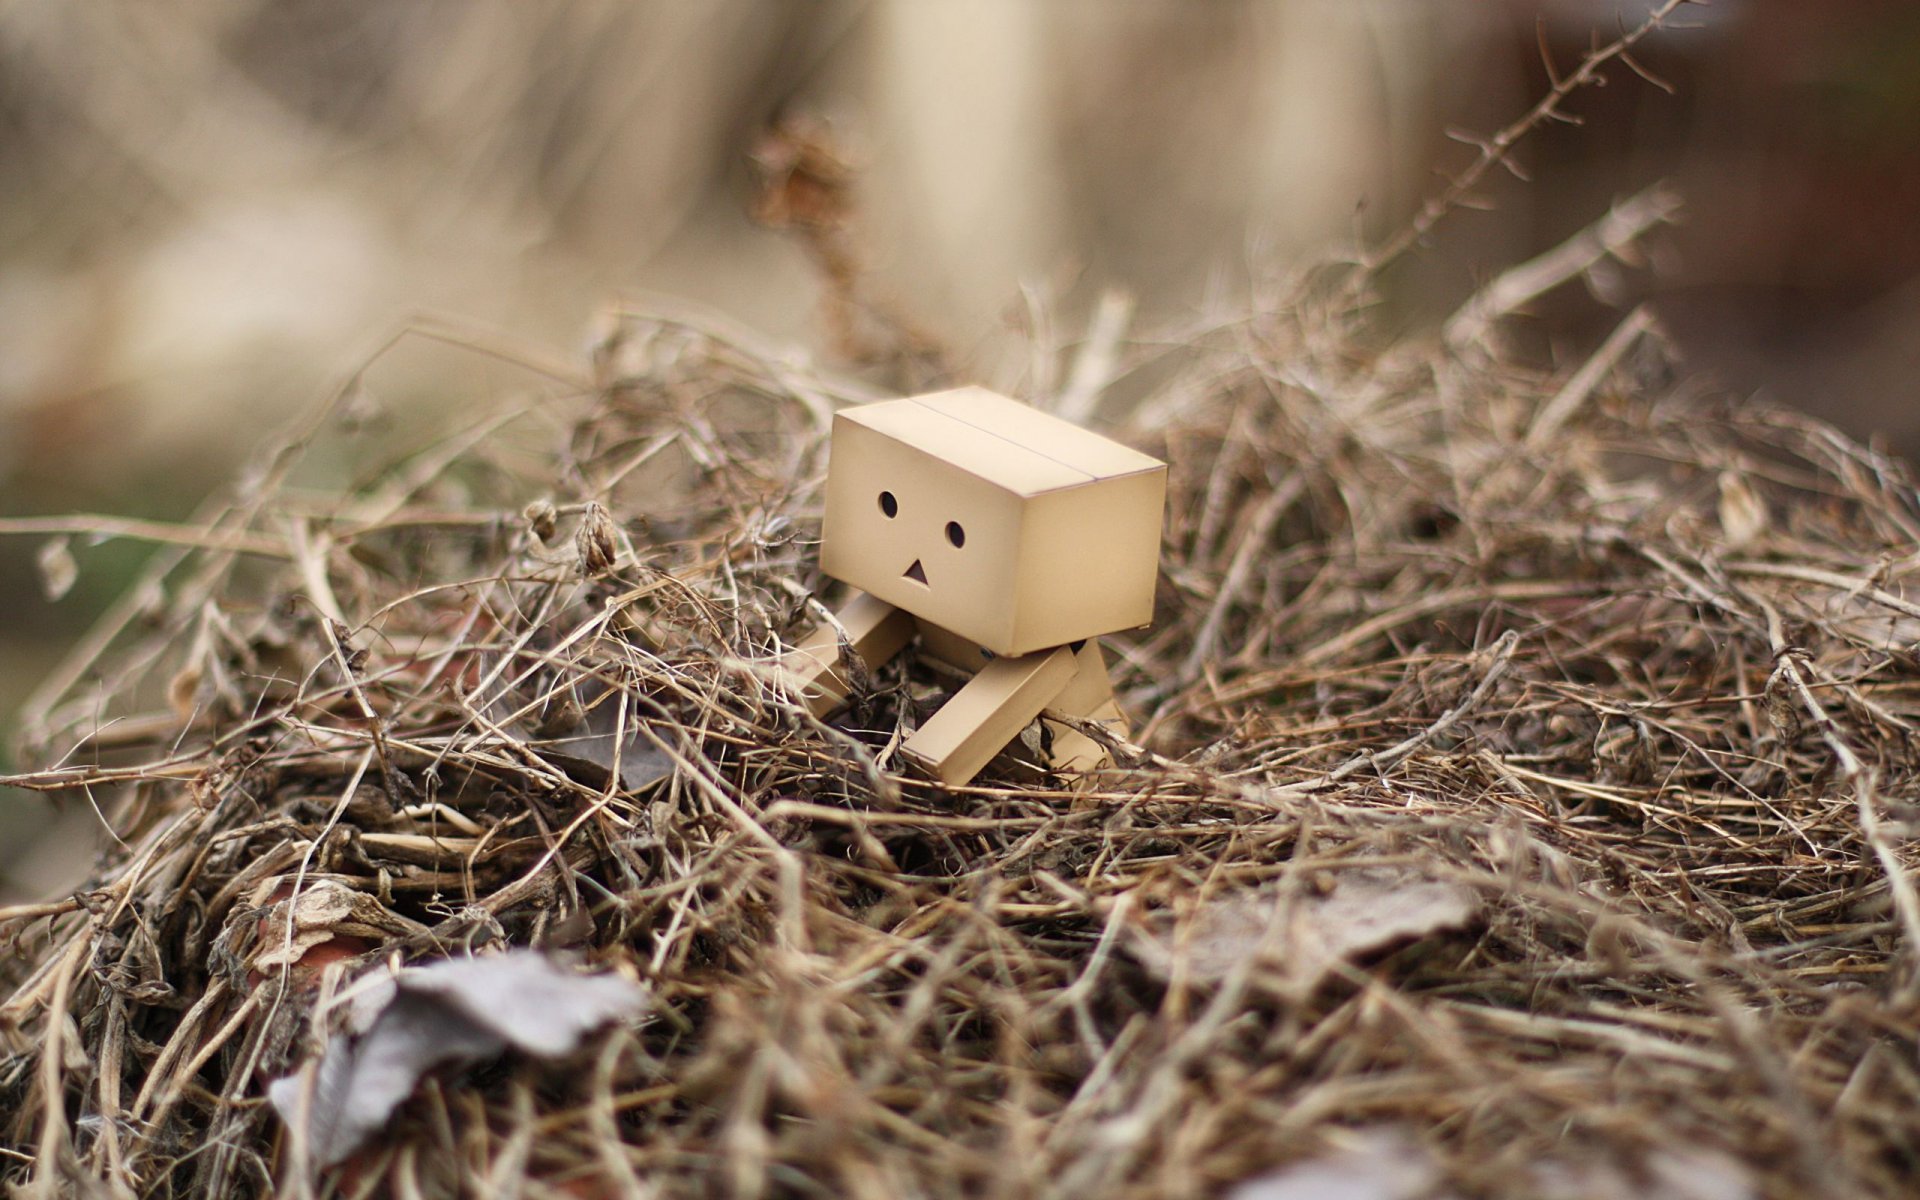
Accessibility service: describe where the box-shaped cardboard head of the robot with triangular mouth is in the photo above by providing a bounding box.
[820,388,1167,655]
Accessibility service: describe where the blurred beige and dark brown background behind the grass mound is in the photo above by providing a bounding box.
[0,0,1920,902]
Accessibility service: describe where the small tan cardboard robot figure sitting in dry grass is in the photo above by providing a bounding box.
[781,388,1167,783]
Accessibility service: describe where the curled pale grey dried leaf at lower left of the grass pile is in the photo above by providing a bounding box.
[267,950,647,1165]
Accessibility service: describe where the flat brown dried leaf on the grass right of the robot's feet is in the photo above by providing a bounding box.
[1135,872,1478,993]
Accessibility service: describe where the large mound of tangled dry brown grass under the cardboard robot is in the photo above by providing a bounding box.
[11,182,1920,1198]
